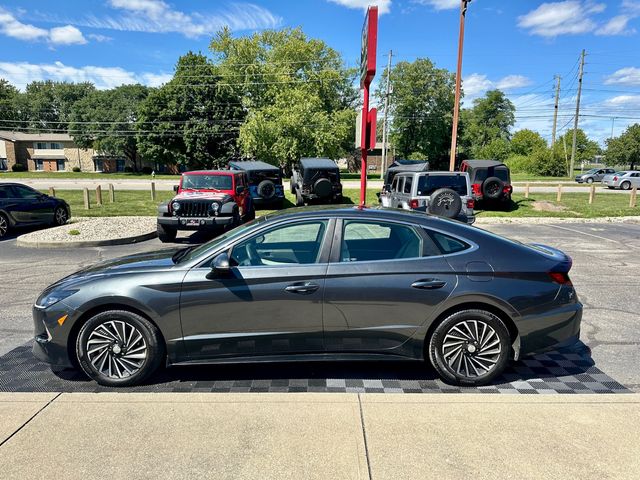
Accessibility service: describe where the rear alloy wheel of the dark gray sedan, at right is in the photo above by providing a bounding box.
[442,320,502,378]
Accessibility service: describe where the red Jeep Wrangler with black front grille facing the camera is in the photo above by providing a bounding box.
[158,170,256,242]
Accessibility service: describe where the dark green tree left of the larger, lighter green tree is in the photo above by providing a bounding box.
[138,52,245,168]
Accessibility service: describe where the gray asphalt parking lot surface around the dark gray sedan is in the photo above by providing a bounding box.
[0,223,640,391]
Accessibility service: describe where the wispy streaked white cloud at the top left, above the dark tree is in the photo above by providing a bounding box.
[72,0,282,38]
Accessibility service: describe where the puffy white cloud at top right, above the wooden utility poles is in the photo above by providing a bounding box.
[518,0,606,37]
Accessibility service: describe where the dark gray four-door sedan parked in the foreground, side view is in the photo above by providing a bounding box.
[33,206,582,386]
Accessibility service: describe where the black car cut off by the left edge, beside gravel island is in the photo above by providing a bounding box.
[0,183,71,238]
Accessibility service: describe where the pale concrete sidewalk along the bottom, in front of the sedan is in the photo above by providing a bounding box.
[0,393,640,480]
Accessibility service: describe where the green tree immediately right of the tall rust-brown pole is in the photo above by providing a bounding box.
[460,90,516,157]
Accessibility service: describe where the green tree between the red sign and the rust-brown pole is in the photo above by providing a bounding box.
[376,58,455,166]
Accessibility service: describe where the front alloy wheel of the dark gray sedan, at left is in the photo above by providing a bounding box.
[86,320,147,379]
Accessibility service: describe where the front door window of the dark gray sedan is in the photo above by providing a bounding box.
[230,220,328,267]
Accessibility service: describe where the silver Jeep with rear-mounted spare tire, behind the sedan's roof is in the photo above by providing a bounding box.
[380,172,476,224]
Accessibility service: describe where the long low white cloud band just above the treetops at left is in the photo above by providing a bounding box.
[0,62,172,90]
